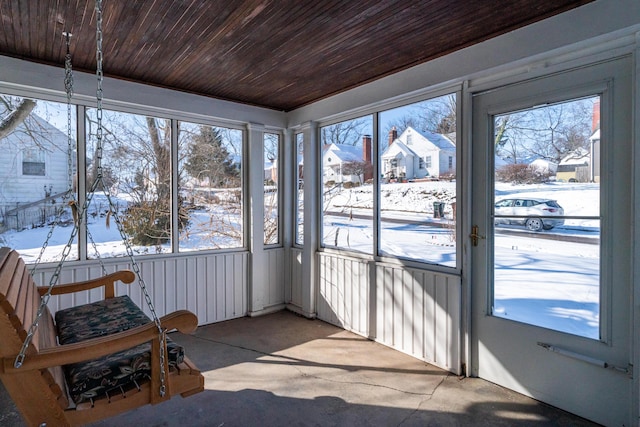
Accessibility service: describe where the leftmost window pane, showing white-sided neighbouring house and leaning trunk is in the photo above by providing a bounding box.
[0,94,78,263]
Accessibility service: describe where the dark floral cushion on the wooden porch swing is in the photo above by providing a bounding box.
[55,295,184,404]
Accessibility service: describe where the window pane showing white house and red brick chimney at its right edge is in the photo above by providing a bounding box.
[320,116,374,254]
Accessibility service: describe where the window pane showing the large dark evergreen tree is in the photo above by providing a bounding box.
[178,122,244,252]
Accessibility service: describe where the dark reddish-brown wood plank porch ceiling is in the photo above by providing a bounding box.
[0,0,592,111]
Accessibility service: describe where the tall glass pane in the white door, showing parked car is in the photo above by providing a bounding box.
[492,96,601,339]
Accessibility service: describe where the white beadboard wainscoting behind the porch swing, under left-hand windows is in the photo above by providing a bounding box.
[34,252,250,325]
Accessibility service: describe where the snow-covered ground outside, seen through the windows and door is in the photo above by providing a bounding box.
[0,182,600,339]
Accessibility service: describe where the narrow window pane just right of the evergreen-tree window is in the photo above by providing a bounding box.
[264,133,280,245]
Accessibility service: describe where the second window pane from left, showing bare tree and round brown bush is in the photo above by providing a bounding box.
[86,108,175,258]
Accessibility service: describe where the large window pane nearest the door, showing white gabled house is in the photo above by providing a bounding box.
[378,94,457,267]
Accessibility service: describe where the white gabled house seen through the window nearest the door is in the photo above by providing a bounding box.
[381,127,456,179]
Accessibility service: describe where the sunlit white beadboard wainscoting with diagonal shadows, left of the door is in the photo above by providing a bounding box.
[317,252,461,374]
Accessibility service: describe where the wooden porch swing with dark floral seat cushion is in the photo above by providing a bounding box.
[0,247,204,426]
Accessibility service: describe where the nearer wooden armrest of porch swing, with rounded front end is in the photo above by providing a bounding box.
[0,310,198,374]
